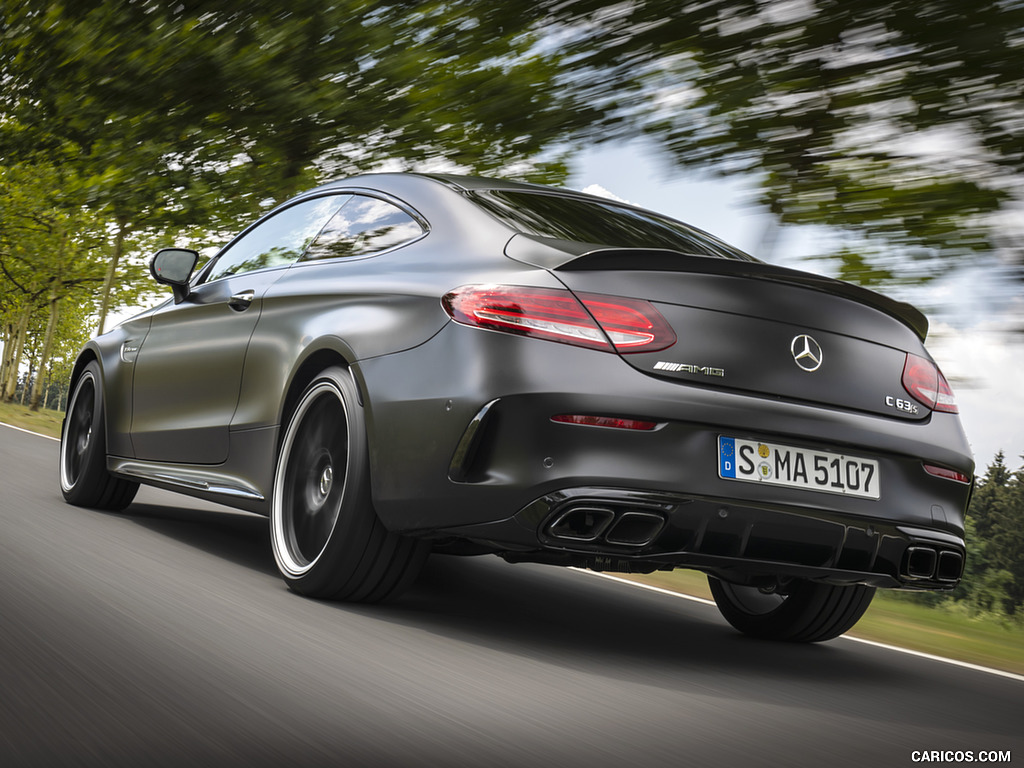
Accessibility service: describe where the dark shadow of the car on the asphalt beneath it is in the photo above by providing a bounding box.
[110,502,1015,736]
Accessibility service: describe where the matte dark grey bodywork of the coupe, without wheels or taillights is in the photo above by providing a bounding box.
[59,174,974,638]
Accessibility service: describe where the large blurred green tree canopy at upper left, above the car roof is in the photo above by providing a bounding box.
[0,0,591,333]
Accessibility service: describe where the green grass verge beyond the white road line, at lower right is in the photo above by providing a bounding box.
[624,570,1024,675]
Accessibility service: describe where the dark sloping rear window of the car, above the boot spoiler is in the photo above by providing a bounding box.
[470,189,758,261]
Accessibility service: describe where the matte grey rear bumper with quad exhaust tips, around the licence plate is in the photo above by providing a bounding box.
[354,325,974,589]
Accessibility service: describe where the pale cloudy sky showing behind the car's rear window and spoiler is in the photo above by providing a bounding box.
[566,143,1024,474]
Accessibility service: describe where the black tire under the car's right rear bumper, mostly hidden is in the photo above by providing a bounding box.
[708,577,874,643]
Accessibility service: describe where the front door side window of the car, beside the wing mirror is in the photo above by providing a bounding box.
[206,195,351,283]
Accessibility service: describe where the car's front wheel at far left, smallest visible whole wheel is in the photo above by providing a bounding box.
[60,360,138,511]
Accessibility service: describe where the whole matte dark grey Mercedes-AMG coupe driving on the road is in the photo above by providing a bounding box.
[60,173,974,641]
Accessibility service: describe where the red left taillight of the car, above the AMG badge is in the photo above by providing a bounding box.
[441,286,676,352]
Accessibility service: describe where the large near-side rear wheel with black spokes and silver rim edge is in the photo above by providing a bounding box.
[270,368,429,602]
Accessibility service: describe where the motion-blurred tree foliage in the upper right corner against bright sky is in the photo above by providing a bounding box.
[544,0,1024,283]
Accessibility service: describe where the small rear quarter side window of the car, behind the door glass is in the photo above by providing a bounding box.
[302,195,424,261]
